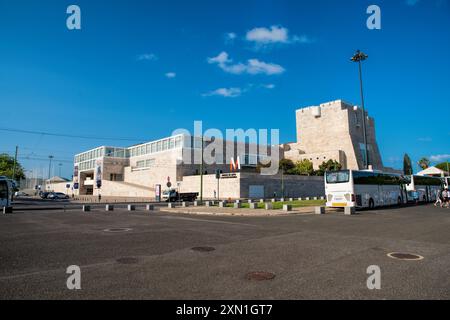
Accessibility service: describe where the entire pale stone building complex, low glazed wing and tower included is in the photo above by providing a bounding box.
[73,100,392,199]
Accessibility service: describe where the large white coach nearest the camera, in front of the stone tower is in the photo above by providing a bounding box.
[324,170,407,209]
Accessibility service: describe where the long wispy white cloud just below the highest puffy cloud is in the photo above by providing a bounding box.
[208,51,286,75]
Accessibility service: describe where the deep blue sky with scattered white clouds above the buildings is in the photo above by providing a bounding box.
[0,0,450,177]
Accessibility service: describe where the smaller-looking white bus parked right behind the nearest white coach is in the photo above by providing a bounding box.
[405,175,443,202]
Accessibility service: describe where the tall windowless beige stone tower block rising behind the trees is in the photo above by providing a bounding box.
[284,100,384,170]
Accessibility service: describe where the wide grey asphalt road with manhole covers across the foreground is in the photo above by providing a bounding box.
[0,205,450,299]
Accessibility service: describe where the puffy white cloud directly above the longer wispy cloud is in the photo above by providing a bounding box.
[245,26,313,47]
